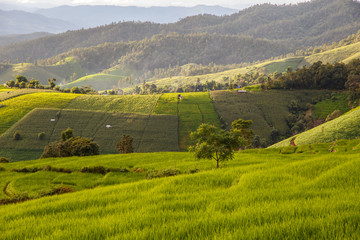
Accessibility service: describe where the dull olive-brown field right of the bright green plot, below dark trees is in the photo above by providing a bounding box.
[210,90,326,140]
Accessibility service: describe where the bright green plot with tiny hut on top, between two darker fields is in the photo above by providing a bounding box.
[155,92,220,149]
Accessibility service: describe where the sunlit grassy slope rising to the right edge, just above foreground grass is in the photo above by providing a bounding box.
[271,105,360,147]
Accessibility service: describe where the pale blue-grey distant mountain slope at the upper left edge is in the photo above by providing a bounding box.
[0,10,77,35]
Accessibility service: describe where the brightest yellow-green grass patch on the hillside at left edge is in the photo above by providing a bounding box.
[0,92,78,134]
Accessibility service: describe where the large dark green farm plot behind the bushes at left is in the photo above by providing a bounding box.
[0,109,179,158]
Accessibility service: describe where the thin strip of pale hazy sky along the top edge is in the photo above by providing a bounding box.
[0,0,307,8]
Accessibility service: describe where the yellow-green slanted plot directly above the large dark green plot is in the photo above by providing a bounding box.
[67,95,160,114]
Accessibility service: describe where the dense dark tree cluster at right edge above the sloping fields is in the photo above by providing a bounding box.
[262,59,360,97]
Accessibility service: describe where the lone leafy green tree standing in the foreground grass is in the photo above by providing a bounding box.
[189,123,244,168]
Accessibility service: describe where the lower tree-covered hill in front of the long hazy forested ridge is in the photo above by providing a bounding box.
[40,33,289,72]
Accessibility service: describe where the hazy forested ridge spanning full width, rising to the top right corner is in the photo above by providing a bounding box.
[0,0,360,61]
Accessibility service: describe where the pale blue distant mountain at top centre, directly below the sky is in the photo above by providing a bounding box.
[36,5,239,28]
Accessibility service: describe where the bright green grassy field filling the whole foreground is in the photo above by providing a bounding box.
[0,146,360,239]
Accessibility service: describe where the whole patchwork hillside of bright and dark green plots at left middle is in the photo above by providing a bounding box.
[0,91,220,161]
